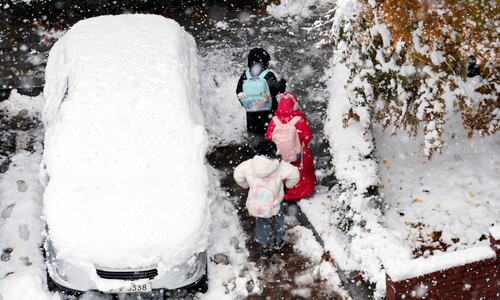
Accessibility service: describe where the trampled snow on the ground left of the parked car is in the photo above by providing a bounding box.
[0,94,59,300]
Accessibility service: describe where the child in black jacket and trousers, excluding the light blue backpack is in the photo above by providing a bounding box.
[236,48,286,136]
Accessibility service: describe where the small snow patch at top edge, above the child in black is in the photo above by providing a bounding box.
[267,0,335,18]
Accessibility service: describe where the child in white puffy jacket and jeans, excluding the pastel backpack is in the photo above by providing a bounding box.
[234,140,300,259]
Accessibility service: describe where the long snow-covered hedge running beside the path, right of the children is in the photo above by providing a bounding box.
[317,0,382,236]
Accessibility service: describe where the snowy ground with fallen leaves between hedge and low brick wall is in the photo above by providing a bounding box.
[376,114,500,257]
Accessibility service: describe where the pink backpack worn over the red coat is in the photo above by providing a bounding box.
[272,116,302,162]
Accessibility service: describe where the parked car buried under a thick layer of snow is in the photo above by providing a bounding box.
[41,15,210,293]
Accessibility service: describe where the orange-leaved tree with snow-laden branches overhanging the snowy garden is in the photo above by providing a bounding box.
[338,0,500,158]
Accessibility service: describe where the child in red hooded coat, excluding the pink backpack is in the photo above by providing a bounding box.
[266,93,316,201]
